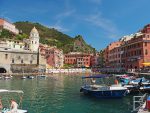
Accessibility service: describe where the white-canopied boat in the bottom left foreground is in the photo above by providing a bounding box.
[0,89,27,113]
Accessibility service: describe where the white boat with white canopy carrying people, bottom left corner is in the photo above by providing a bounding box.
[0,89,27,113]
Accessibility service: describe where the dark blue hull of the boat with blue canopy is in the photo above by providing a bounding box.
[80,88,127,98]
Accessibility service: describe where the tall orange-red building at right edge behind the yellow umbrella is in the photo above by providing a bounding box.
[121,24,150,70]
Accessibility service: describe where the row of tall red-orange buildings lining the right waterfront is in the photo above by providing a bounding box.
[104,24,150,71]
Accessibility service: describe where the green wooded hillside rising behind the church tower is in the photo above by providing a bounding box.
[14,21,94,53]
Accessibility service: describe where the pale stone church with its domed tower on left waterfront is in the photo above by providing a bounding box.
[0,28,39,72]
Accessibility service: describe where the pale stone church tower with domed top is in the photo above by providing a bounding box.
[29,27,40,52]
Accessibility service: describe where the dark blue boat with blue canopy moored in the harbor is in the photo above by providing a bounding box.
[80,75,128,98]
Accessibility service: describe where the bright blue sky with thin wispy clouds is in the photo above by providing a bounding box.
[0,0,150,50]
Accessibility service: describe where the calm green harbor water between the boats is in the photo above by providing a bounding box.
[0,74,133,113]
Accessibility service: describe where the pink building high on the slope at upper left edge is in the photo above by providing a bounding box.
[0,18,19,34]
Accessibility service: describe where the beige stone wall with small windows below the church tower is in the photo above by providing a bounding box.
[0,50,38,72]
